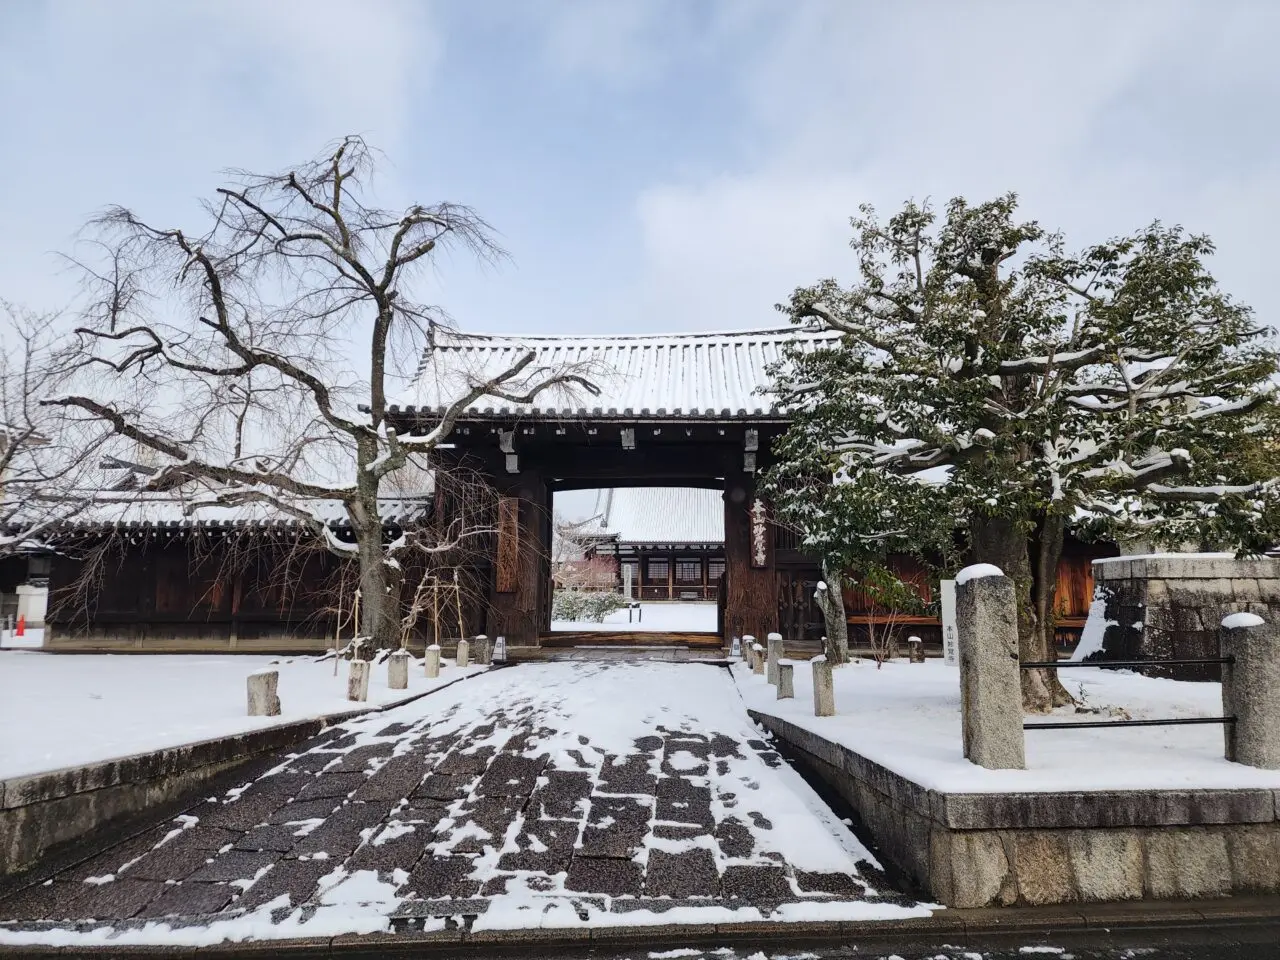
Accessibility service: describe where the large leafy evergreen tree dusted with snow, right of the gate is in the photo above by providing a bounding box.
[767,195,1280,710]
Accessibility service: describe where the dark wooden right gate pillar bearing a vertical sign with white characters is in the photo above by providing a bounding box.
[722,472,778,643]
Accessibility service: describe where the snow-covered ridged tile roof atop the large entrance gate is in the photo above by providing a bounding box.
[392,328,836,420]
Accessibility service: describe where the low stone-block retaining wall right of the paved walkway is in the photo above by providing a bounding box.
[750,710,1280,908]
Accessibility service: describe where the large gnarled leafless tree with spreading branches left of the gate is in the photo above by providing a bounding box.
[49,137,596,646]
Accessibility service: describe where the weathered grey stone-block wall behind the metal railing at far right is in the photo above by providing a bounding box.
[1089,553,1280,680]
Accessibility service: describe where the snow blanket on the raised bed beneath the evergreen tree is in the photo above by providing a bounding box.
[733,660,1280,792]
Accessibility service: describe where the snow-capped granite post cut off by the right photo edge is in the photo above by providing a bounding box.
[1222,613,1280,771]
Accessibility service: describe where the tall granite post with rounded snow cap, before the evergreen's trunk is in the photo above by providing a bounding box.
[956,563,1027,771]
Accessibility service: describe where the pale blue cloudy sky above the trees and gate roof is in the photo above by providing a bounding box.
[0,0,1280,343]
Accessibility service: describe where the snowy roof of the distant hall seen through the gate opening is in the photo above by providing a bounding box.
[595,486,724,544]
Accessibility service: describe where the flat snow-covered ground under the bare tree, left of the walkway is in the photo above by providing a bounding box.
[0,650,484,780]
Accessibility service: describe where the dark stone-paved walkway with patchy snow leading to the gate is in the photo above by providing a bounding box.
[0,662,920,942]
